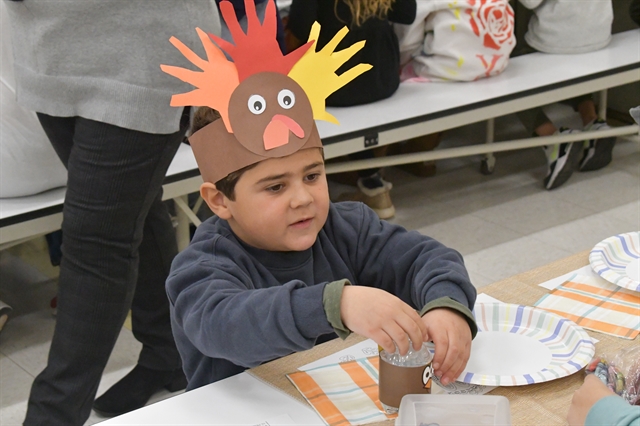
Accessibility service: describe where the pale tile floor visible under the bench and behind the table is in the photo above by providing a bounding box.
[0,108,640,426]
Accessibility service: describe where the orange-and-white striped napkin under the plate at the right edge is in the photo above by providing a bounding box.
[535,274,640,340]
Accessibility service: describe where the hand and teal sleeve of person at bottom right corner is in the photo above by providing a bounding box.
[567,374,640,426]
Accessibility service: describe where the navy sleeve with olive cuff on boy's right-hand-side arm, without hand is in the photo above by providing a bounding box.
[335,203,476,322]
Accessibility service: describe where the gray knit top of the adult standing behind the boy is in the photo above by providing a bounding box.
[5,0,220,134]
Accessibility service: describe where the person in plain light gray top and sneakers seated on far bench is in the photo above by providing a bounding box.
[518,0,615,189]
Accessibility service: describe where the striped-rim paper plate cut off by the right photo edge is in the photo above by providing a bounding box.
[589,232,640,291]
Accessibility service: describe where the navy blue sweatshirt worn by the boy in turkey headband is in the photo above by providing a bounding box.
[167,203,476,390]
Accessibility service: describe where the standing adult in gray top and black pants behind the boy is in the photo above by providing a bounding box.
[6,0,220,426]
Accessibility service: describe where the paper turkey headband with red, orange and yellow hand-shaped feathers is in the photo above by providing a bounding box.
[160,0,371,183]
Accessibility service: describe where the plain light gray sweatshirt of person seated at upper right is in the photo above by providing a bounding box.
[520,0,613,53]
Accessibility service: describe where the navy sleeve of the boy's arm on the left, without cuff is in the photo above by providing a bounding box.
[167,255,333,368]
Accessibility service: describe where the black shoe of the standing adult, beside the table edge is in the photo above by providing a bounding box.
[93,365,187,417]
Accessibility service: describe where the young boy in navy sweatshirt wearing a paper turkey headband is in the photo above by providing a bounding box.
[163,1,477,390]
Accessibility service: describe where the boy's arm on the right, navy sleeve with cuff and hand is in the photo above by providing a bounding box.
[330,204,477,381]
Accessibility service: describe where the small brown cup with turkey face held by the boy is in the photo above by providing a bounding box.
[378,357,433,410]
